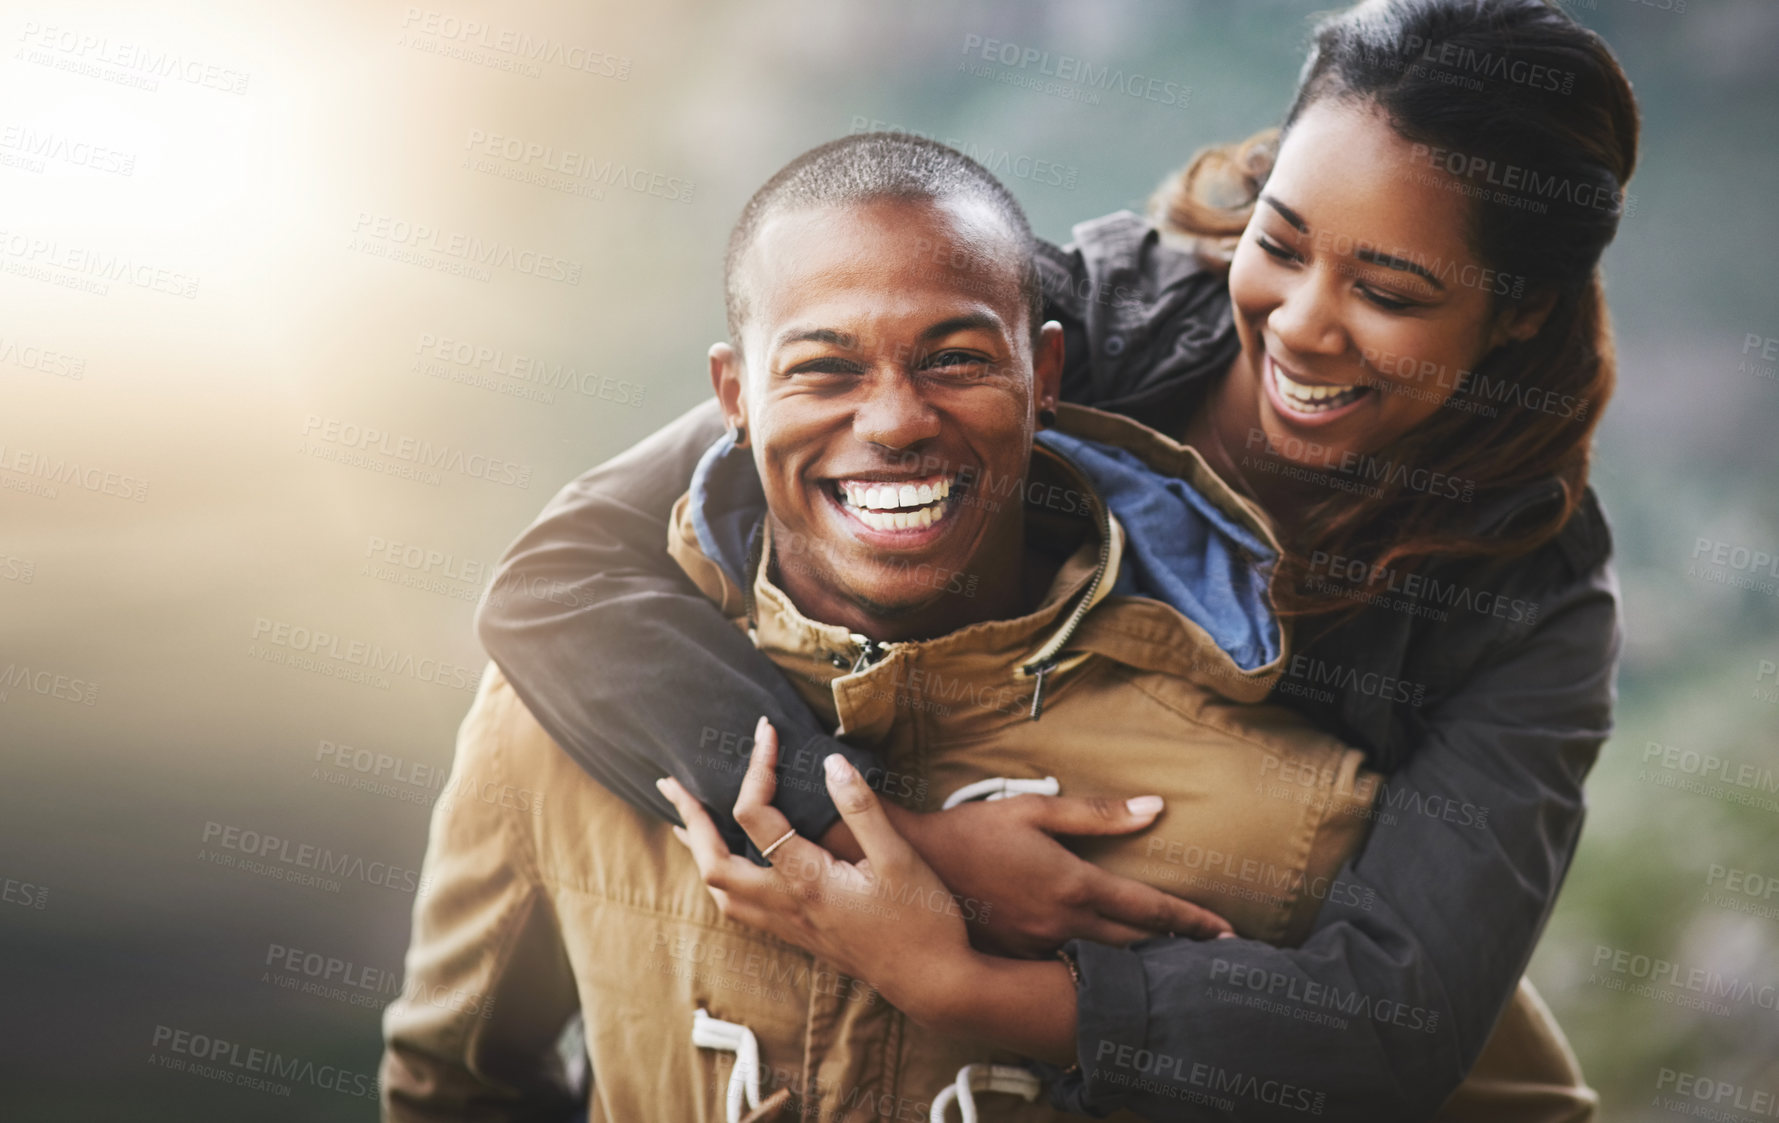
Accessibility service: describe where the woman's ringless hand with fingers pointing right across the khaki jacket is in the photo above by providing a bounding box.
[825,796,1235,959]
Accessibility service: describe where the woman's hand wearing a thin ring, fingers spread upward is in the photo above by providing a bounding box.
[656,717,977,1022]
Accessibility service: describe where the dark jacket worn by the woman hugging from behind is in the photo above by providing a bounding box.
[477,214,1621,1119]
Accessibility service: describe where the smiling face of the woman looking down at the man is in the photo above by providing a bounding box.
[1220,100,1542,468]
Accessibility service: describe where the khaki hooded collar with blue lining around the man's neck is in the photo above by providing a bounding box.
[669,406,1284,715]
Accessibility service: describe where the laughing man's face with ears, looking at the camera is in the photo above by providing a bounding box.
[712,199,1062,634]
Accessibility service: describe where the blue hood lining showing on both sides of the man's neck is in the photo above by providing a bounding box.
[690,429,1281,671]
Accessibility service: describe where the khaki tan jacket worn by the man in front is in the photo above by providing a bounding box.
[382,409,1592,1123]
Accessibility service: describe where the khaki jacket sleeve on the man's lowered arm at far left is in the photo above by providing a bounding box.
[379,675,582,1123]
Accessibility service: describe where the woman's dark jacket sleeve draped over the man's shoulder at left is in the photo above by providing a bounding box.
[477,400,875,852]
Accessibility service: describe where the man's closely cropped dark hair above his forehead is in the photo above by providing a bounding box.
[722,132,1044,347]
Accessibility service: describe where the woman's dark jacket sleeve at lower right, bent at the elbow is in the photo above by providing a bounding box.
[1055,566,1619,1119]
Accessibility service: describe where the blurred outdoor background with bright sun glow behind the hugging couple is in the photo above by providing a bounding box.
[0,0,1779,1121]
